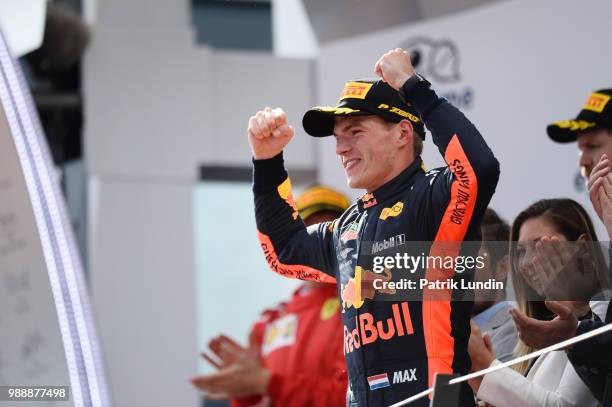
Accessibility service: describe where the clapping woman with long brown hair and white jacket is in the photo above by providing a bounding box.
[468,199,609,407]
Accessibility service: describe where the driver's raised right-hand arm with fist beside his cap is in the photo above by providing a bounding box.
[375,48,499,236]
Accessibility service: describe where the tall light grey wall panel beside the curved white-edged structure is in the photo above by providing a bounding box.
[89,177,199,407]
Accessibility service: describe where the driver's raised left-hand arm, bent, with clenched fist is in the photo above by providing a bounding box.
[248,108,335,282]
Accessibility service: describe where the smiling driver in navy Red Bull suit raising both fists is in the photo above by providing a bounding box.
[248,49,499,406]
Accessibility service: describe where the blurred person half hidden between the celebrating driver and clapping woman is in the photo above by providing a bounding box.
[472,208,518,362]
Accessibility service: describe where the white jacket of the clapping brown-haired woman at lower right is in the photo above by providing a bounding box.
[476,351,597,407]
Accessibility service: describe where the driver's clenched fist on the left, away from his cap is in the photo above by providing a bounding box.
[247,107,293,160]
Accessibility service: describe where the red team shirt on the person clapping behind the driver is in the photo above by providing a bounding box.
[231,284,347,407]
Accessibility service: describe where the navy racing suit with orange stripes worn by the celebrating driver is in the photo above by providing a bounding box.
[253,79,499,406]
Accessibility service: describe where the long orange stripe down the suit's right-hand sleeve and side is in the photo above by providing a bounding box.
[422,134,478,387]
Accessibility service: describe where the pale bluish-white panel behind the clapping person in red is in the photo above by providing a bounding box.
[194,182,300,373]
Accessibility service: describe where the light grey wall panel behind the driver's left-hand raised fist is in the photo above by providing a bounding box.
[210,51,315,169]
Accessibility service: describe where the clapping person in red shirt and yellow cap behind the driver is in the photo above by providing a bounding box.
[192,186,349,407]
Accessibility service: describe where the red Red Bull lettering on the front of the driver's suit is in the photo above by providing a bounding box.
[344,302,414,355]
